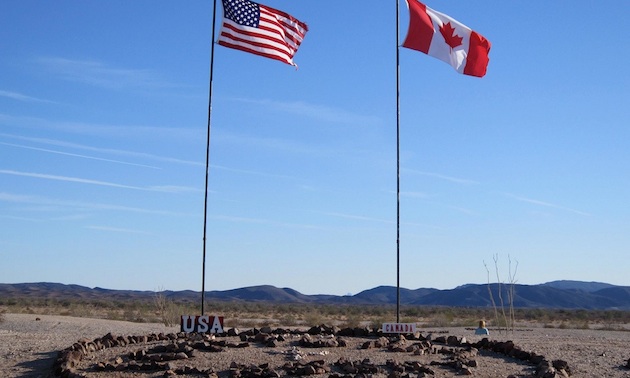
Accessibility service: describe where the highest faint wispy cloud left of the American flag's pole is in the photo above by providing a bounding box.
[36,57,179,90]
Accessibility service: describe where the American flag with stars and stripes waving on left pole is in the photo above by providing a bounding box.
[218,0,308,66]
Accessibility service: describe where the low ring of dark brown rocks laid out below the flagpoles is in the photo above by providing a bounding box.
[54,325,576,378]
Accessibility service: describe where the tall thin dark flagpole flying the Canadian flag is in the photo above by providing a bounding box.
[396,0,400,323]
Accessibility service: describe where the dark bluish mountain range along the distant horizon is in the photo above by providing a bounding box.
[0,281,630,310]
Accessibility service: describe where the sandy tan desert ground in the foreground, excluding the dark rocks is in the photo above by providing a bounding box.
[0,314,630,378]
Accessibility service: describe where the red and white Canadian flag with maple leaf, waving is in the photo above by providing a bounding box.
[403,0,491,77]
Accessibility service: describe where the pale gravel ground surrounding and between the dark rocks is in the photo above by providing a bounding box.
[0,314,630,378]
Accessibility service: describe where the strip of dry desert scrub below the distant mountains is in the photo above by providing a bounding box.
[0,292,630,330]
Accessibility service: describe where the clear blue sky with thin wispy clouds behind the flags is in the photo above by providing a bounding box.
[0,0,630,294]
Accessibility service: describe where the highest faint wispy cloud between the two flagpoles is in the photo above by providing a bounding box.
[233,98,381,126]
